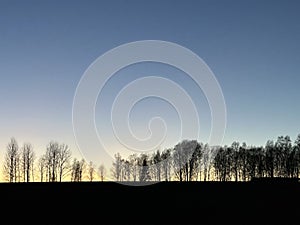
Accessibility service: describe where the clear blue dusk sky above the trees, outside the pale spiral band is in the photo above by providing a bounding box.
[0,0,300,171]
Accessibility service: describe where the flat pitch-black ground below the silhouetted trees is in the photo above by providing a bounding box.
[0,181,300,225]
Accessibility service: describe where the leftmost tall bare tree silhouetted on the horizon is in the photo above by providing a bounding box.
[3,138,19,182]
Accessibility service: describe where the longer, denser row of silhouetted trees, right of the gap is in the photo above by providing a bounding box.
[111,135,300,181]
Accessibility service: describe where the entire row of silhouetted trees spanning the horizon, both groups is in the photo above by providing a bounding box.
[2,135,300,182]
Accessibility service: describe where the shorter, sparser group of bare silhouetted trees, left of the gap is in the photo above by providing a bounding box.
[2,138,106,182]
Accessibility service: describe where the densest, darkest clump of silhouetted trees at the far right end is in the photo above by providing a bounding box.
[214,136,300,181]
